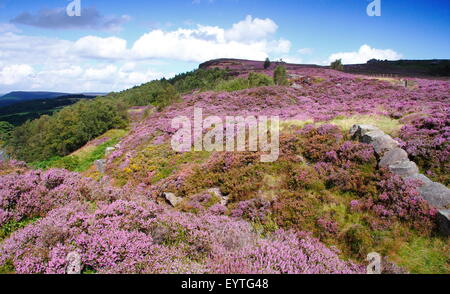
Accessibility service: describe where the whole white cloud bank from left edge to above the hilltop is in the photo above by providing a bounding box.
[0,16,291,92]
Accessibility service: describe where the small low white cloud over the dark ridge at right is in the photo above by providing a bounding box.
[328,45,403,64]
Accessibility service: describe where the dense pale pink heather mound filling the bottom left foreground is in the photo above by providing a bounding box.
[0,200,362,273]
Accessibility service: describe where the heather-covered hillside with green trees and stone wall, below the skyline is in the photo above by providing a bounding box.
[0,59,450,274]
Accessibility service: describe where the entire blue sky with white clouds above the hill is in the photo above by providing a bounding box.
[0,0,450,93]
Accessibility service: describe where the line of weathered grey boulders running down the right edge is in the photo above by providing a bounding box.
[350,125,450,236]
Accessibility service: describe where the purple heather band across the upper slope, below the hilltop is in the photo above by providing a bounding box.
[109,68,450,176]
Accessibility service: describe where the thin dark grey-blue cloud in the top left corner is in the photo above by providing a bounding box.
[11,7,130,30]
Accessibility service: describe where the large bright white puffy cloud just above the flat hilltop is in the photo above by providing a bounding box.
[131,16,291,62]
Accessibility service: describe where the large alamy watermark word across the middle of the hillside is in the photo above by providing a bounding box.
[171,108,280,162]
